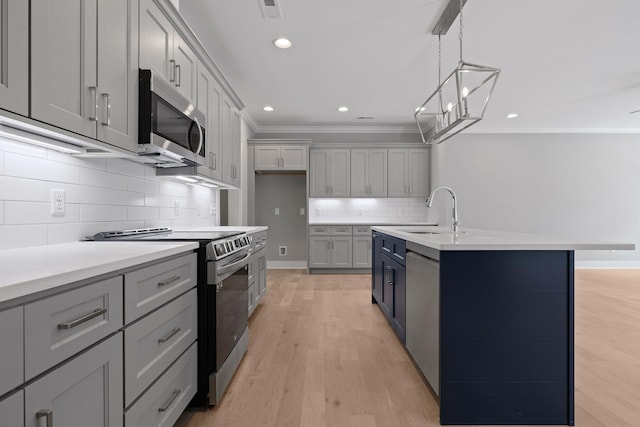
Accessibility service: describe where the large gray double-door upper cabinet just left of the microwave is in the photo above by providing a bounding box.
[31,0,138,151]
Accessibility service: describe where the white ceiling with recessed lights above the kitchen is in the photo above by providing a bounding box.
[180,0,640,132]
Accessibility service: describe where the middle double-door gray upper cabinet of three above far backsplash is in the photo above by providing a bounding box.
[351,149,387,197]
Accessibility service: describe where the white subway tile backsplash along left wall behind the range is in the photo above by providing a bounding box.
[0,139,218,249]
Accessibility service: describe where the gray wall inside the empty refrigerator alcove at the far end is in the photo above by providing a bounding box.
[255,175,307,261]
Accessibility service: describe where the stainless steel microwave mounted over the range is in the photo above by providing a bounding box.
[138,70,206,168]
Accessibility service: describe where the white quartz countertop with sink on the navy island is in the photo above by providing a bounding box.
[373,226,635,251]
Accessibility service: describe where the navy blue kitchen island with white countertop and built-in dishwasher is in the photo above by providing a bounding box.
[372,226,634,425]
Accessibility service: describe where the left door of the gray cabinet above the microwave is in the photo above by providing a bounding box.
[140,0,174,83]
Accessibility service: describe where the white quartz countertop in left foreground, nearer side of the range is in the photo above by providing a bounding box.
[0,242,198,304]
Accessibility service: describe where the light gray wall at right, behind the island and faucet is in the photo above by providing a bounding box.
[432,134,640,266]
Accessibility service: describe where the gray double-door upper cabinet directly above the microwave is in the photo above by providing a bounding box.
[140,0,198,105]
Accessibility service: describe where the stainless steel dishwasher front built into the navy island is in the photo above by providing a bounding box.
[406,251,440,396]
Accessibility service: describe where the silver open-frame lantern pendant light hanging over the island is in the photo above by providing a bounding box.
[414,0,500,144]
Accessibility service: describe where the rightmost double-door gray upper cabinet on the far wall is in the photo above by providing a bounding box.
[388,148,429,197]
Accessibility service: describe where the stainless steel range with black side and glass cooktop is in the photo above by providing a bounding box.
[88,227,251,407]
